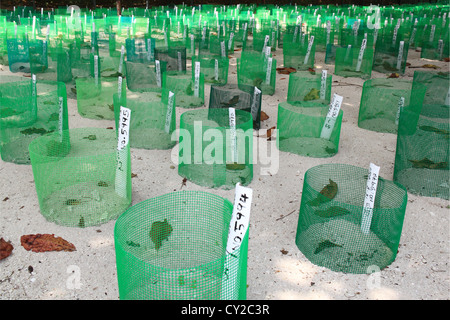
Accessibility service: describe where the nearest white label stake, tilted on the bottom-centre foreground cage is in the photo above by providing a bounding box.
[220,183,253,300]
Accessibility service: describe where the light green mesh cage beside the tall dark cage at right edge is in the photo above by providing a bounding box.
[358,78,425,133]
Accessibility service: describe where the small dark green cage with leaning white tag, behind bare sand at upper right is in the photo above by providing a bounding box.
[334,45,373,79]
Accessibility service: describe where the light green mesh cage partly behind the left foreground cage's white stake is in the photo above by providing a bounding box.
[114,90,176,149]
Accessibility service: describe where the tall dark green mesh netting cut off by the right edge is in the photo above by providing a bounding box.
[394,72,450,199]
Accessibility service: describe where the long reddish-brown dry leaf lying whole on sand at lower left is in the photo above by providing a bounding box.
[20,233,77,252]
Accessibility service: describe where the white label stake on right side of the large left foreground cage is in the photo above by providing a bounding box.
[115,106,131,198]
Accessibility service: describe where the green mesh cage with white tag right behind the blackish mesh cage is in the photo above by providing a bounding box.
[236,51,277,95]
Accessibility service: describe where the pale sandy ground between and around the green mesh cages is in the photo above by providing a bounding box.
[0,41,450,300]
